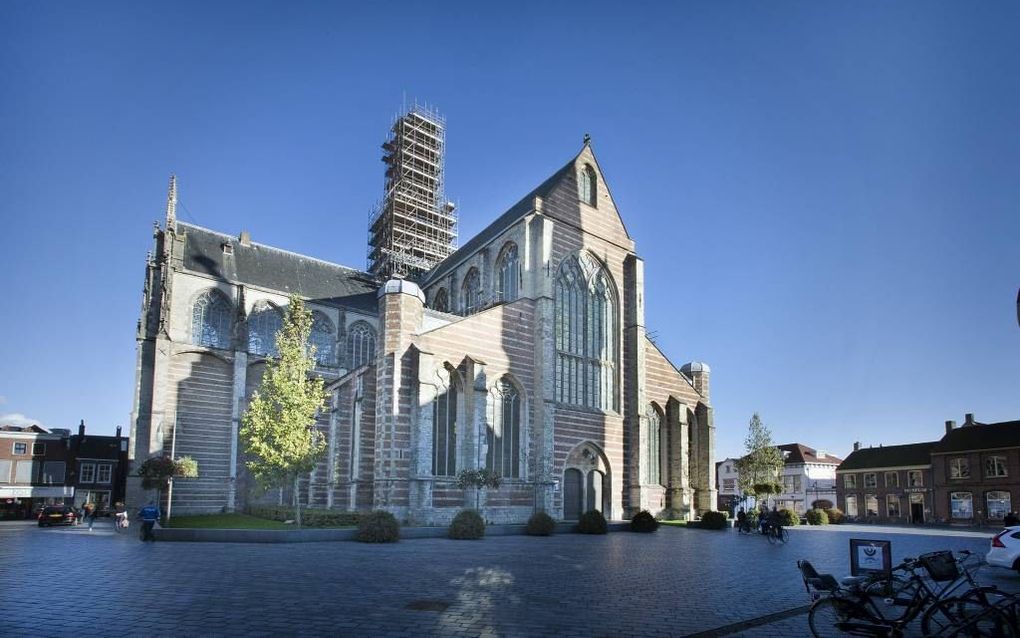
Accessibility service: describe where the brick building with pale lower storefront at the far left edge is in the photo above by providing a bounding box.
[0,425,74,519]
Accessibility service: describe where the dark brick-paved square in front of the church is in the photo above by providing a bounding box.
[0,523,1020,638]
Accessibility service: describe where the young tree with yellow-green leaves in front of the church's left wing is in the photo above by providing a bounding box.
[240,295,326,528]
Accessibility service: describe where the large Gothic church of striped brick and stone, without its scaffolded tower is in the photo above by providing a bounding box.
[129,143,716,525]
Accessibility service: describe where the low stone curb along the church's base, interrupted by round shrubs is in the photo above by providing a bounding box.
[153,522,630,543]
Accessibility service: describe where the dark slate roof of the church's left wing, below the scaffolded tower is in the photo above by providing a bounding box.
[177,222,380,313]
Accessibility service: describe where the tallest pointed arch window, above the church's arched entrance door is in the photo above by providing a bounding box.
[553,253,617,410]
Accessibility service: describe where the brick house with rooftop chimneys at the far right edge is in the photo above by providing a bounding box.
[931,414,1020,525]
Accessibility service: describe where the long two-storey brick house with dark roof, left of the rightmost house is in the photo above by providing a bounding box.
[835,441,936,524]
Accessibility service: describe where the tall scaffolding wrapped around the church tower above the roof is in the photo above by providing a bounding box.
[368,103,457,279]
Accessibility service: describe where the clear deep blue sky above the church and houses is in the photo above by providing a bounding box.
[0,0,1020,458]
